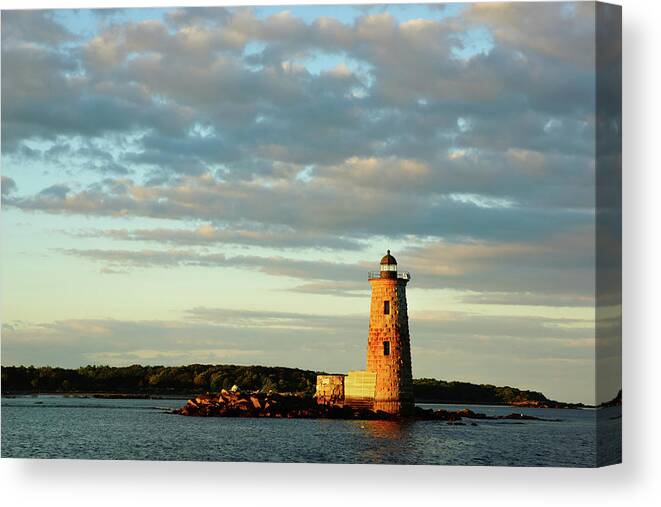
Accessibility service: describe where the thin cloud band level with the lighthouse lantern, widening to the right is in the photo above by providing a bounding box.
[58,224,595,306]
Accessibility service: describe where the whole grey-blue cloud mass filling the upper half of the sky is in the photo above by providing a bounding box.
[2,5,594,249]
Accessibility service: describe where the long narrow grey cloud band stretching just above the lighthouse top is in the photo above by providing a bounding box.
[6,169,593,244]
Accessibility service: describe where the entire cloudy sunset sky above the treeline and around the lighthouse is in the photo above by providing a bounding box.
[1,3,619,403]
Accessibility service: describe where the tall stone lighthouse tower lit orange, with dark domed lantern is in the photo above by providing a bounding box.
[367,250,413,415]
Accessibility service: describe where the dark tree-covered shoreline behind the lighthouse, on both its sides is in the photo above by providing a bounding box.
[2,364,576,407]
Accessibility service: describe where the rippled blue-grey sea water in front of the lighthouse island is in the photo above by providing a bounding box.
[2,396,621,467]
